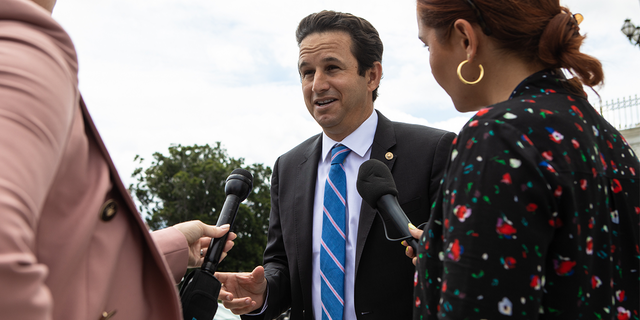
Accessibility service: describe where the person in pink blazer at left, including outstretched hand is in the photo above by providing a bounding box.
[0,0,235,320]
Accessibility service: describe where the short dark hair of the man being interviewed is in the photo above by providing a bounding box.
[296,10,383,101]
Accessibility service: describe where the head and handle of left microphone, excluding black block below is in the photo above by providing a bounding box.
[202,169,253,274]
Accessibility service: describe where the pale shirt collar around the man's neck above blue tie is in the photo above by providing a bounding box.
[321,110,378,161]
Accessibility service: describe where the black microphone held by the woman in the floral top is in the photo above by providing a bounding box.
[356,159,418,253]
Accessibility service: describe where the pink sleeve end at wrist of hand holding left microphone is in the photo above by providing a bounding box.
[151,227,189,283]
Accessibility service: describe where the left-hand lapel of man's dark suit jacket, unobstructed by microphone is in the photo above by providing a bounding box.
[291,135,322,310]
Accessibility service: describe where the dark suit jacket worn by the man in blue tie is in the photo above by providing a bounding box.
[248,113,455,320]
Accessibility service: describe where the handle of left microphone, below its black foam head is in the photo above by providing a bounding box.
[202,194,240,274]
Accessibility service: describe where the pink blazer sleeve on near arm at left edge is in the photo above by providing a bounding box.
[0,20,79,319]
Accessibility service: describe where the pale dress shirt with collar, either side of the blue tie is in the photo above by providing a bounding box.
[311,111,378,320]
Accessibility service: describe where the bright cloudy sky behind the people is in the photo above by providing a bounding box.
[53,0,640,183]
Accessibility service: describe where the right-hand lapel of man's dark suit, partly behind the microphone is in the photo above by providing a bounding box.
[356,110,396,278]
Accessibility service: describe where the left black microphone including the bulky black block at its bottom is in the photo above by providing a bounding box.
[180,169,253,320]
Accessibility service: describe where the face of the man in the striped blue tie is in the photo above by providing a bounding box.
[298,31,382,141]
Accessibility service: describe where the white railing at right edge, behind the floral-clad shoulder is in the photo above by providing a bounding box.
[600,94,640,130]
